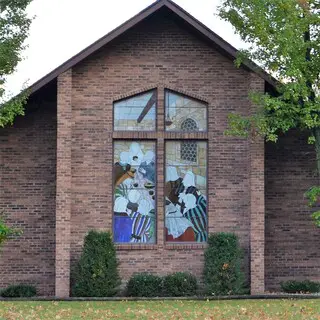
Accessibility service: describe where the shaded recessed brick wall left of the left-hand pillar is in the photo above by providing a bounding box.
[0,96,57,295]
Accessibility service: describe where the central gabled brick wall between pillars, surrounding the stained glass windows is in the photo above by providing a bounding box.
[71,10,263,288]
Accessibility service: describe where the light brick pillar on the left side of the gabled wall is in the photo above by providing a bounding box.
[55,69,73,297]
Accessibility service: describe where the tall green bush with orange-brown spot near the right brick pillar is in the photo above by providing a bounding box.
[204,232,246,295]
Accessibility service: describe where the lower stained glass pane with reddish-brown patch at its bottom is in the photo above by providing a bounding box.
[165,140,208,242]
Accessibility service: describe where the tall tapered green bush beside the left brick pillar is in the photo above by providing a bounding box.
[71,231,120,297]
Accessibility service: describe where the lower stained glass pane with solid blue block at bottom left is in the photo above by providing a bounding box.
[113,140,156,243]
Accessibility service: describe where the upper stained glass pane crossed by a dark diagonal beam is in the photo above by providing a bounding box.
[114,90,157,131]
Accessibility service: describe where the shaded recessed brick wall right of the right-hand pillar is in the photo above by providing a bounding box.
[265,133,320,290]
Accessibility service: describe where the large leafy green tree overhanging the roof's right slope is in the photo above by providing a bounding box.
[218,0,320,227]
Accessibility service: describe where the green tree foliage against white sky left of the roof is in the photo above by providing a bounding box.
[0,0,32,127]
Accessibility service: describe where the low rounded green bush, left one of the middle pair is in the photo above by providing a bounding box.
[127,273,163,297]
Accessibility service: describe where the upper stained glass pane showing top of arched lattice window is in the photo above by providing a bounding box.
[165,90,207,132]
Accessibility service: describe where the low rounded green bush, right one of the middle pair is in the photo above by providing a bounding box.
[163,272,198,297]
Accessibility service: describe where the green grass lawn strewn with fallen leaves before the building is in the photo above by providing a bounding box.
[0,299,320,320]
